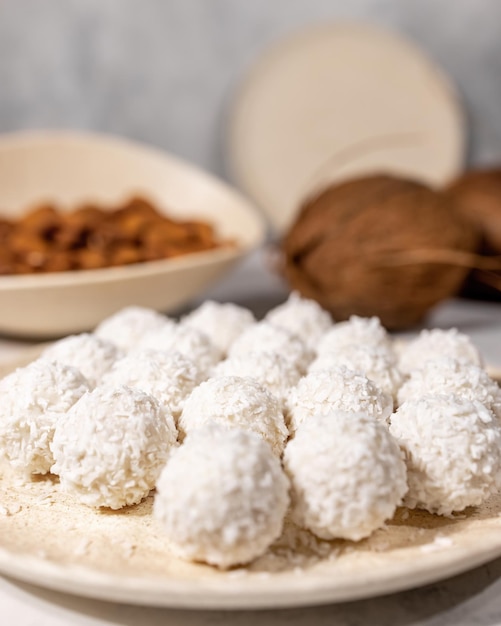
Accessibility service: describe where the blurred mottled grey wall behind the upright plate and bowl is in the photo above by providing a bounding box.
[0,0,501,180]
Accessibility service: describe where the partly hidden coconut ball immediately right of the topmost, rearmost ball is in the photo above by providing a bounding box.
[317,315,392,355]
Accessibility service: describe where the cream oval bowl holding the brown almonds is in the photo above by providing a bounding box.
[0,131,265,337]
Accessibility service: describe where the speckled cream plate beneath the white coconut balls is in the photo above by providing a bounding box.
[0,348,501,609]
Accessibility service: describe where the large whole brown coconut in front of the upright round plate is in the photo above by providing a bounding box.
[283,175,479,329]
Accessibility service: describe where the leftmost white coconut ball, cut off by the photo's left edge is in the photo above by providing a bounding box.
[0,358,90,474]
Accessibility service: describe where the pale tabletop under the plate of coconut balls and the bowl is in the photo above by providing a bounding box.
[0,246,501,626]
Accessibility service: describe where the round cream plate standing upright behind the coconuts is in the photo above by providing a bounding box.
[228,23,465,231]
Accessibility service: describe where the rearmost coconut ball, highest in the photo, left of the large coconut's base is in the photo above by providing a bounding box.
[265,291,332,350]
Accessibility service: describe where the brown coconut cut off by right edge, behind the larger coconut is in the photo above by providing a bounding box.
[447,168,501,300]
